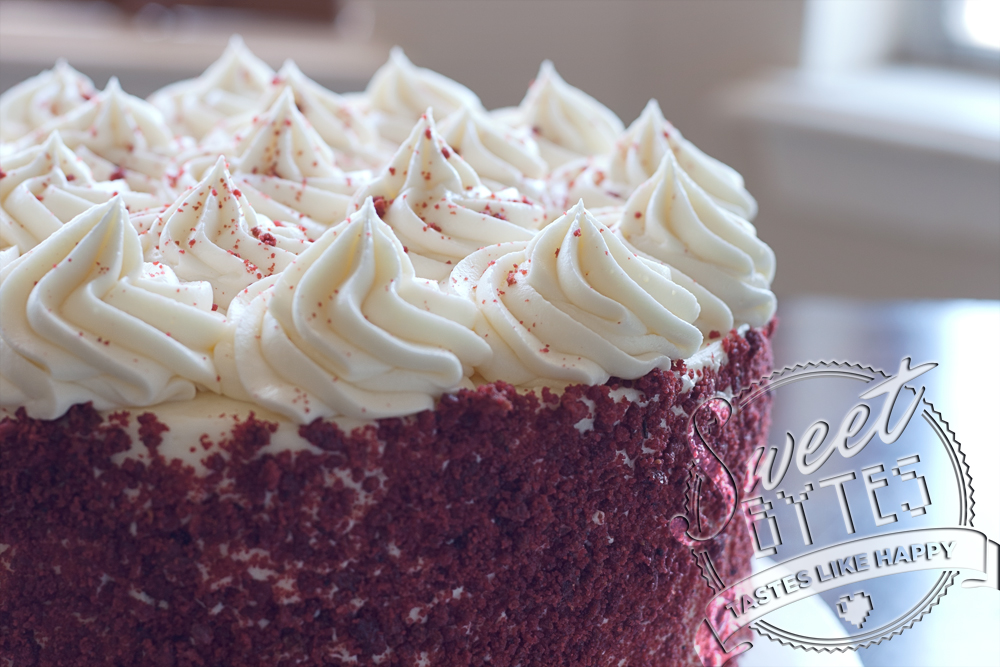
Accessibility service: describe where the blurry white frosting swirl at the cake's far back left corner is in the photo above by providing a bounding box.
[0,59,97,143]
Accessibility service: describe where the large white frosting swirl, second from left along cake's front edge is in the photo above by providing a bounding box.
[216,198,490,423]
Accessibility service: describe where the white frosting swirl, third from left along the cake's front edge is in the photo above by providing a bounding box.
[449,201,702,386]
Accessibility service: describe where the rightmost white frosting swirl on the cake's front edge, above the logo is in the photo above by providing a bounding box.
[618,152,776,327]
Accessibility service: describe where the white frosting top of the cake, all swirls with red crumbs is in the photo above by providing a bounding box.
[0,37,775,423]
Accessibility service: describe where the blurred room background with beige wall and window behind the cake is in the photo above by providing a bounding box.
[0,0,1000,299]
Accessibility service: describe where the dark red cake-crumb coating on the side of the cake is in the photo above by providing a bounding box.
[0,328,771,667]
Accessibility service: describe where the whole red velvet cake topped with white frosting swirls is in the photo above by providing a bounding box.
[0,40,775,667]
